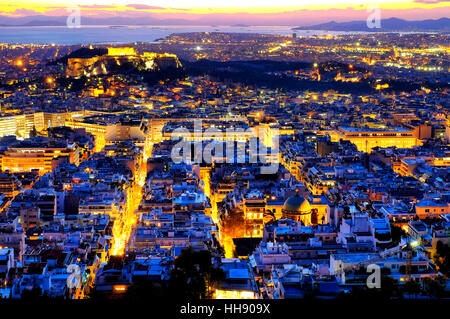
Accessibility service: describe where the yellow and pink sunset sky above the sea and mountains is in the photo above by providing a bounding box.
[0,0,450,25]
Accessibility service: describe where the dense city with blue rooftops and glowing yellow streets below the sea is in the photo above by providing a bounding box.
[0,30,450,300]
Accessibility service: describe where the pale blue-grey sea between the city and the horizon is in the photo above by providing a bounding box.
[0,25,358,45]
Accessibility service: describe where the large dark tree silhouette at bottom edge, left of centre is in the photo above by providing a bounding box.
[169,248,225,299]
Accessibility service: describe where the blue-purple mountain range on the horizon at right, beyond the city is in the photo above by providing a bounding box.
[293,18,450,32]
